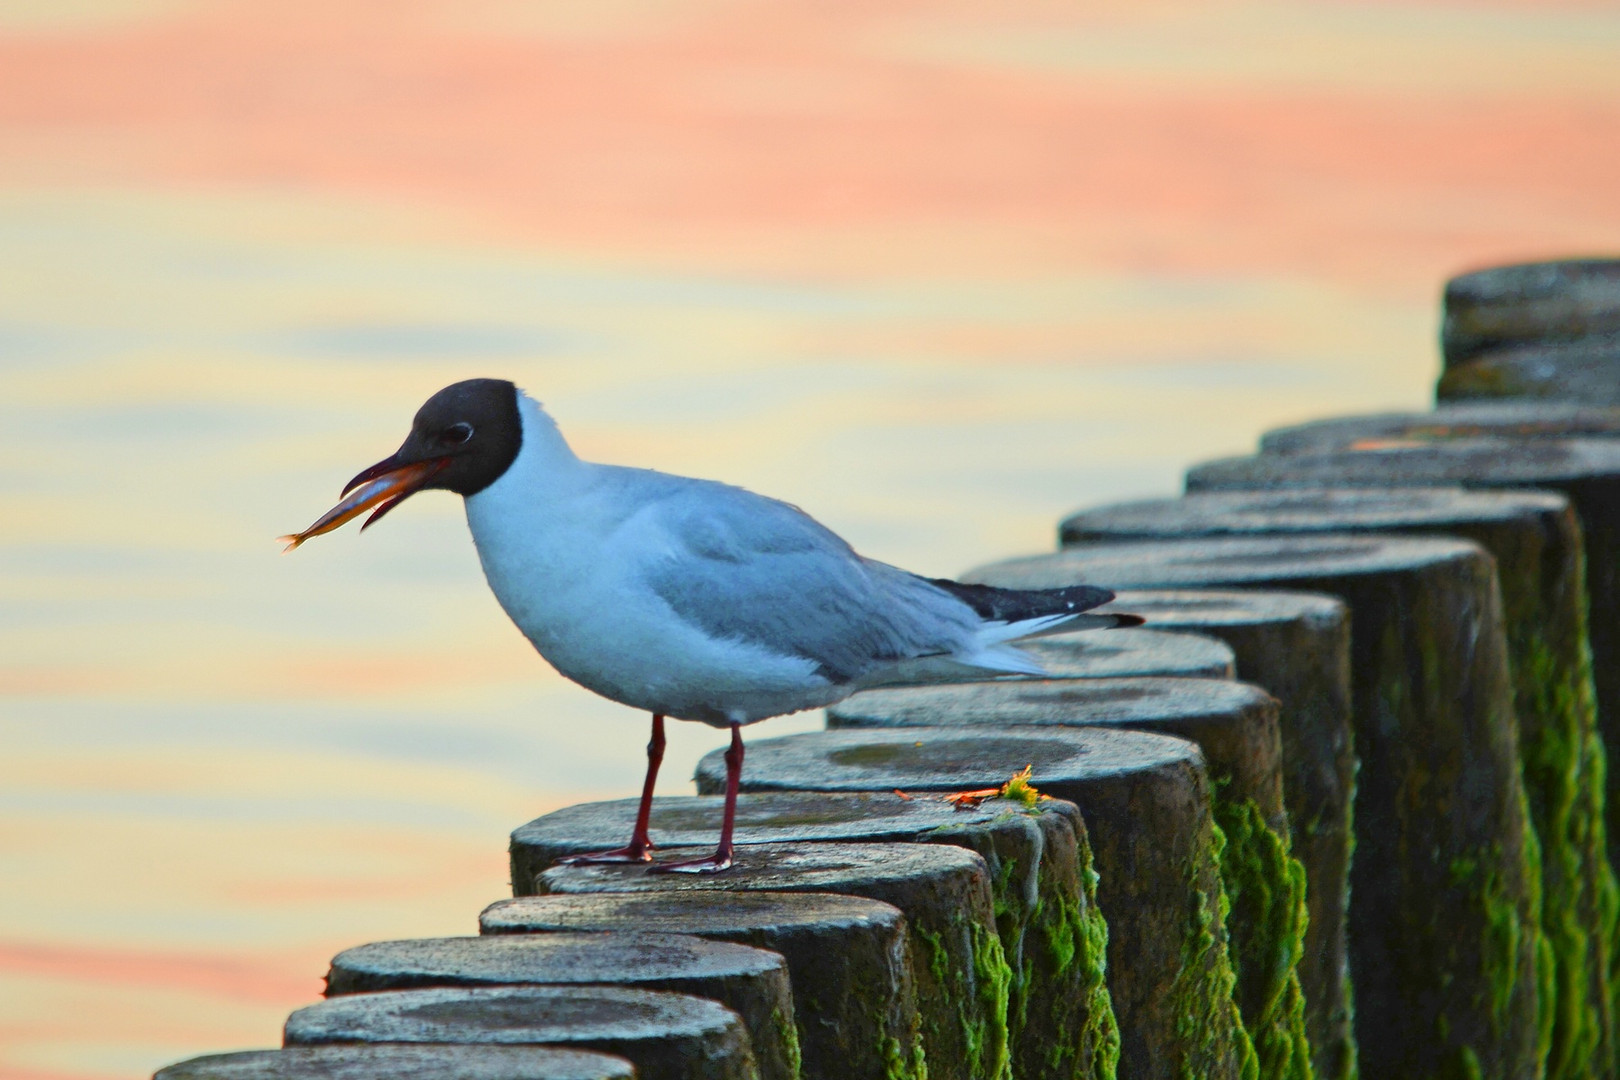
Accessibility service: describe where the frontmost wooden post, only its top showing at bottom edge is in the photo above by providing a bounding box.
[152,1043,635,1080]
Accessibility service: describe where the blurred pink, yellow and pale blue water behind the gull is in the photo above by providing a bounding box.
[0,0,1620,1080]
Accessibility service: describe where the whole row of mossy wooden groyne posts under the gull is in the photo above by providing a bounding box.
[159,261,1620,1080]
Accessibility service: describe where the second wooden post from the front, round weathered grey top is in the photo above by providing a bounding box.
[285,986,760,1080]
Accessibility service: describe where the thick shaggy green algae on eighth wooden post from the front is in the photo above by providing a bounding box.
[1215,785,1315,1080]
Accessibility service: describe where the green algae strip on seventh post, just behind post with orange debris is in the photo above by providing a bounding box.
[1170,823,1260,1080]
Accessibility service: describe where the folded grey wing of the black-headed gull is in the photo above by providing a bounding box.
[646,481,978,683]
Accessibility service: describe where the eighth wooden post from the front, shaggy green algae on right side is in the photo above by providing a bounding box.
[822,678,1312,1080]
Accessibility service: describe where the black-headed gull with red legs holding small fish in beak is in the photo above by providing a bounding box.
[282,379,1142,873]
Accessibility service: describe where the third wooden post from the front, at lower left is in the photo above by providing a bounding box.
[326,933,799,1080]
